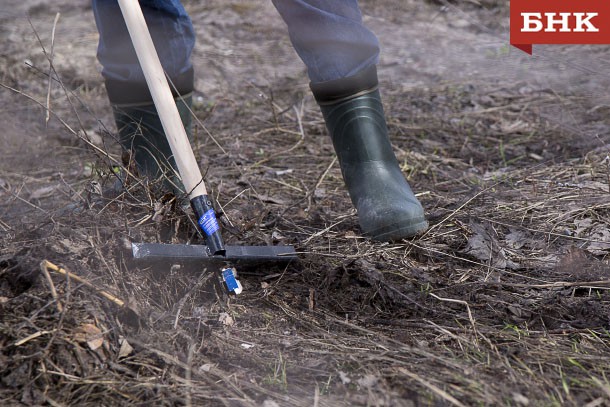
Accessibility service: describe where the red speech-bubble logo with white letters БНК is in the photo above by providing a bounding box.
[510,0,610,54]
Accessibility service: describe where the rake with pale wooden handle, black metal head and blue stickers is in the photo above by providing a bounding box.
[119,0,297,294]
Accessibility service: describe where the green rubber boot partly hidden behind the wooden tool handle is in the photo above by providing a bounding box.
[112,94,192,195]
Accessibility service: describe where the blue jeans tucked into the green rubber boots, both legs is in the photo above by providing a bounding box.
[92,0,379,87]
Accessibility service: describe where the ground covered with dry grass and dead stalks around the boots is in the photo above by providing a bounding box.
[0,0,610,407]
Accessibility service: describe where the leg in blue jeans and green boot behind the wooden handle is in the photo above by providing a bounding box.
[93,0,195,193]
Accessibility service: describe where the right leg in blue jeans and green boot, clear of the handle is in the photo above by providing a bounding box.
[274,0,428,241]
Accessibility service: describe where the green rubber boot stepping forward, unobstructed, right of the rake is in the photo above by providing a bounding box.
[311,66,428,242]
